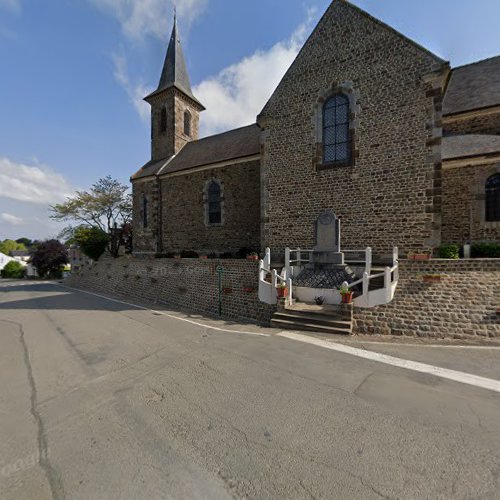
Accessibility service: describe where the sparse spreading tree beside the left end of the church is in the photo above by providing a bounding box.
[51,176,132,257]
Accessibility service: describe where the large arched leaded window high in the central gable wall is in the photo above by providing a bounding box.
[323,94,351,165]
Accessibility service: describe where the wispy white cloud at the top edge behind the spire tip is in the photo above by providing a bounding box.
[90,0,208,40]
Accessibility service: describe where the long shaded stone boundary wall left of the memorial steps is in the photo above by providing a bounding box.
[65,257,276,325]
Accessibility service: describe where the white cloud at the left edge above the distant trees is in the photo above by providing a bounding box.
[0,157,74,204]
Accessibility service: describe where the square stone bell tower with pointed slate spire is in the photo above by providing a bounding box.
[144,16,205,161]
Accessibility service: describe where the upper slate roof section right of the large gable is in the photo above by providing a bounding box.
[443,56,500,115]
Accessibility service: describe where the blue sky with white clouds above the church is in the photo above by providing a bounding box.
[0,0,500,240]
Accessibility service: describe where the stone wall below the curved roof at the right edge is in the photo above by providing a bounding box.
[442,164,500,245]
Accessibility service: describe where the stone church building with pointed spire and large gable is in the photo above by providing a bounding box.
[131,0,500,255]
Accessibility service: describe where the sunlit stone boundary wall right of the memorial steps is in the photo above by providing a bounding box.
[354,259,500,339]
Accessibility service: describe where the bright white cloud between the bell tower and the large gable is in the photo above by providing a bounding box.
[193,9,316,135]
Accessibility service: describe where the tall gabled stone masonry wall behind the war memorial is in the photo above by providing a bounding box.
[258,2,445,253]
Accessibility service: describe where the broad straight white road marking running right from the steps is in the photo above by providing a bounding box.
[278,332,500,392]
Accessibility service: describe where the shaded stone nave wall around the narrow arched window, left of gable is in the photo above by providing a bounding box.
[161,161,260,253]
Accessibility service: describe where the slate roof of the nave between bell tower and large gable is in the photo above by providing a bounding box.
[132,124,260,180]
